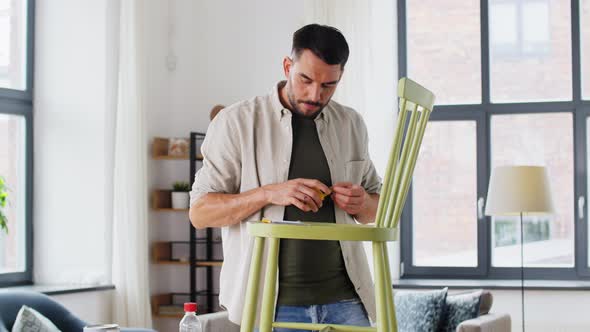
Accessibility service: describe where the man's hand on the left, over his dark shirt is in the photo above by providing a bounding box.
[262,179,332,212]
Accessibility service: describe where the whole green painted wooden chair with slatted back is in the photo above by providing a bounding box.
[240,78,434,332]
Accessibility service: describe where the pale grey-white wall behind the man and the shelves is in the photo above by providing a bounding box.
[146,0,303,331]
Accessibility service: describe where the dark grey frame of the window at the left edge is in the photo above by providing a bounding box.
[0,0,35,287]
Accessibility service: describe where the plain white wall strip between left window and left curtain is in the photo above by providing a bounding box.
[33,0,110,283]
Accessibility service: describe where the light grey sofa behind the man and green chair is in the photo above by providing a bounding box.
[199,291,511,332]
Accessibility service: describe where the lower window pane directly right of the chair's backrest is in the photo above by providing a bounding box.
[412,121,477,266]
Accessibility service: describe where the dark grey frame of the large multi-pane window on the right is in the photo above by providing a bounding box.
[397,0,590,280]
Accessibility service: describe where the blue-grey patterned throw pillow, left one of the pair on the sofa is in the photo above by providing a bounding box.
[394,287,447,332]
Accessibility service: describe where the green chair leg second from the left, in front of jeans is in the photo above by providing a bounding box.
[260,238,280,332]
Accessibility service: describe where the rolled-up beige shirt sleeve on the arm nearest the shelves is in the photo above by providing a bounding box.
[190,109,242,206]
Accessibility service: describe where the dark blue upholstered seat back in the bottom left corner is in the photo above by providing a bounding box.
[0,290,154,332]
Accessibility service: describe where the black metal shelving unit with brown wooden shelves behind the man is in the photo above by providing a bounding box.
[150,132,223,319]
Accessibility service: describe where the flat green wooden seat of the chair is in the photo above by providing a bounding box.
[248,221,397,242]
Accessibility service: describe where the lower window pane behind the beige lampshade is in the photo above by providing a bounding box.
[490,112,574,267]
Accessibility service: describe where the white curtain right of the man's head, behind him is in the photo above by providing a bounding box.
[304,0,399,278]
